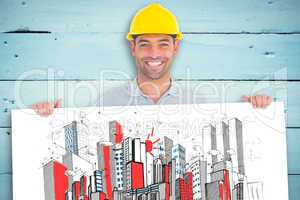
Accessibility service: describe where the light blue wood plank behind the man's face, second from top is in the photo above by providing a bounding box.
[0,33,300,80]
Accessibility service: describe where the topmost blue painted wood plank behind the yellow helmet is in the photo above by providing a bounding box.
[0,0,300,33]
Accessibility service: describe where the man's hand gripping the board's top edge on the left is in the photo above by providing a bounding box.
[32,99,61,117]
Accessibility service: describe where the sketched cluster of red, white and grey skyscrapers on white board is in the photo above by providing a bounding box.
[44,118,263,200]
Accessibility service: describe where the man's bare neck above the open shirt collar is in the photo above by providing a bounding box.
[137,74,171,103]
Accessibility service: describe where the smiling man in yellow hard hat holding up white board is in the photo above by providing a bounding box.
[33,3,272,116]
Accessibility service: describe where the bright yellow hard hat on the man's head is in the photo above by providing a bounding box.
[127,3,183,40]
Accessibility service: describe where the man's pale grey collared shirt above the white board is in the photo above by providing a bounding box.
[98,78,207,106]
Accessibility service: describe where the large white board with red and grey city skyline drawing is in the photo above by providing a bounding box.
[12,103,288,200]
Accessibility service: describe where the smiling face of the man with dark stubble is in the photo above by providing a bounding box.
[130,34,179,80]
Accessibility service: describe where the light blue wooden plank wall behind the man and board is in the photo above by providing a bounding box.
[0,0,300,200]
